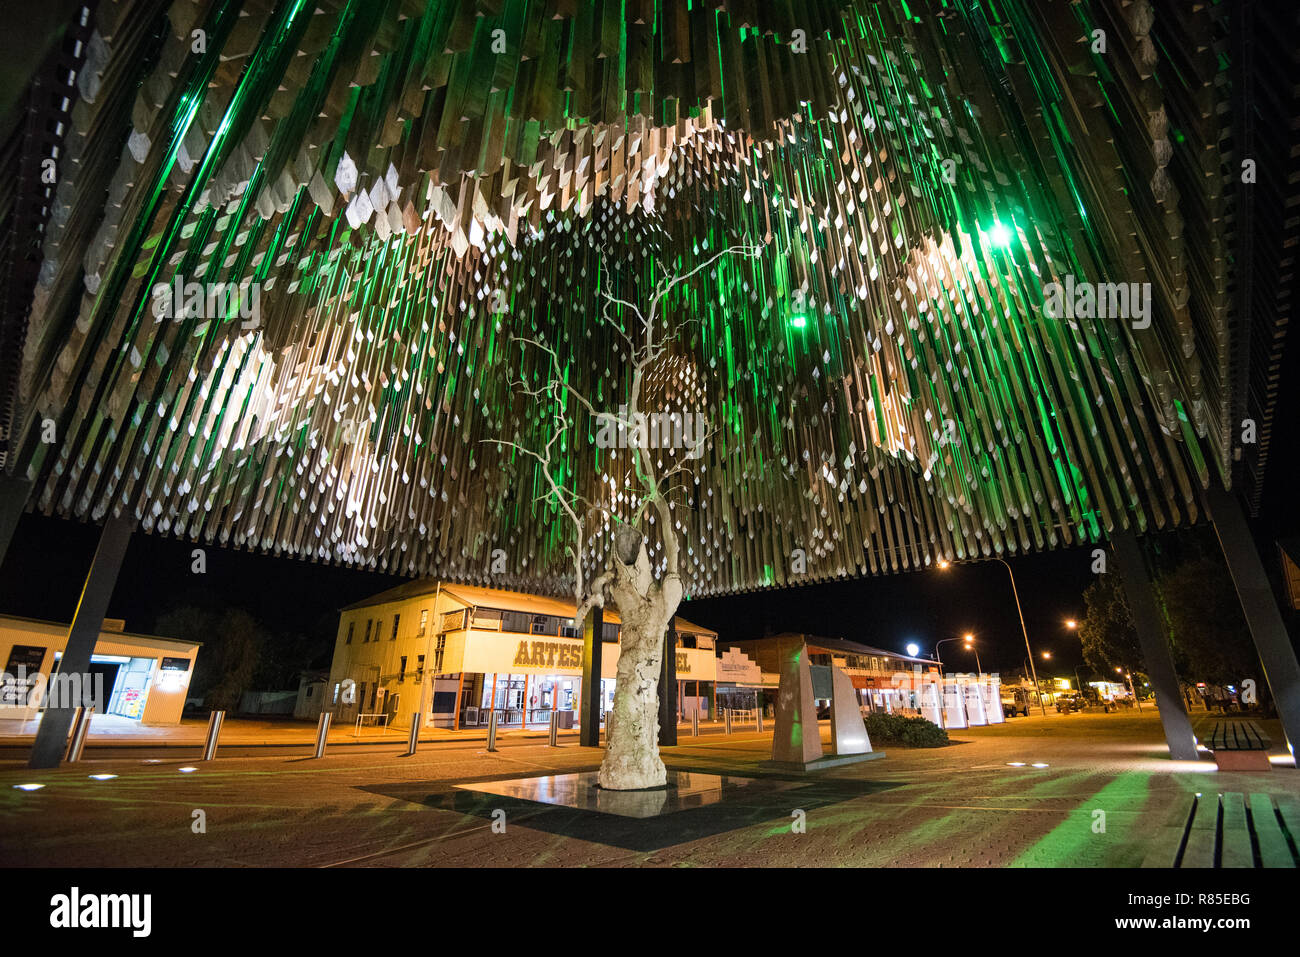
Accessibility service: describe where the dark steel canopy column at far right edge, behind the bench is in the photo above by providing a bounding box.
[1205,482,1300,757]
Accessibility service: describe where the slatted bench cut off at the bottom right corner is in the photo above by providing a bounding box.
[1141,793,1300,867]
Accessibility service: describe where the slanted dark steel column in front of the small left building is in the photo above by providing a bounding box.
[27,516,135,767]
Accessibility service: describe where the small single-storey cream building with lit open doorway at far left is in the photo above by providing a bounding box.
[0,615,200,724]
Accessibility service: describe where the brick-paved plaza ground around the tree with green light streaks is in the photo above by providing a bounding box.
[0,711,1300,867]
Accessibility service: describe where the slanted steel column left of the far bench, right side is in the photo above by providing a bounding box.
[1110,531,1197,761]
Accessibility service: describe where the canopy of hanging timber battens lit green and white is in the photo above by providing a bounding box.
[4,0,1239,596]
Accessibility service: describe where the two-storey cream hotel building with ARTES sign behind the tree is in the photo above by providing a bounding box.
[326,581,716,728]
